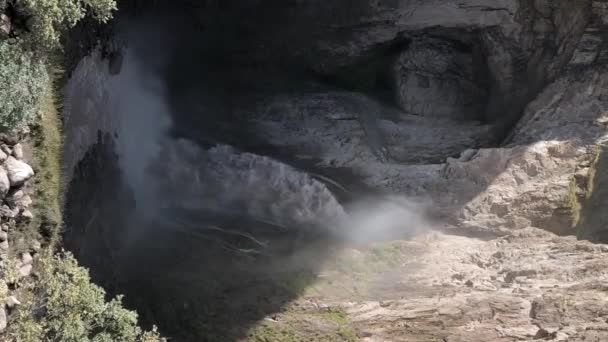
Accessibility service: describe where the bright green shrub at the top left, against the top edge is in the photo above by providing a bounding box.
[16,0,116,50]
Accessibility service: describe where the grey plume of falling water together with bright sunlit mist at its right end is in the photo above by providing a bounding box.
[83,16,430,251]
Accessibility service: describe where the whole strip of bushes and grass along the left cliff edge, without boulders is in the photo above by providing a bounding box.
[0,0,160,342]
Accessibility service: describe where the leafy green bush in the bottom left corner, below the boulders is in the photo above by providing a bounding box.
[11,254,160,342]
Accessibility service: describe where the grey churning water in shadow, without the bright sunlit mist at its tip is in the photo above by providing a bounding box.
[66,44,345,248]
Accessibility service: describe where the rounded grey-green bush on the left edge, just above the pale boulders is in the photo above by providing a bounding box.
[0,41,49,130]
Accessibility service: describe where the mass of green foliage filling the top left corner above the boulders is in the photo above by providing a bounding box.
[0,0,116,130]
